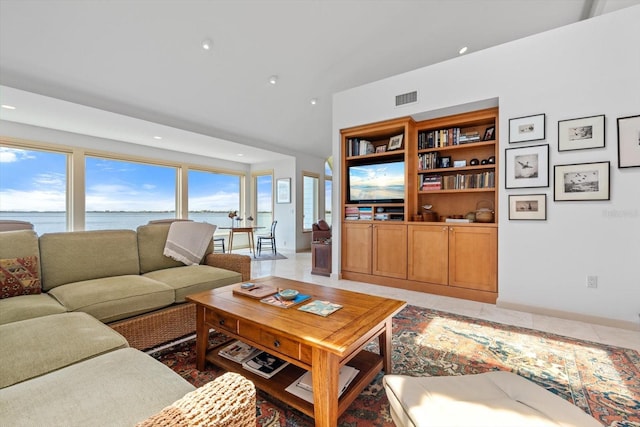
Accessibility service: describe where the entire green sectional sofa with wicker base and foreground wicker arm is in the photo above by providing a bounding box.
[0,224,255,427]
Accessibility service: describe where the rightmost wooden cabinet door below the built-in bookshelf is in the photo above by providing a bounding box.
[449,227,498,292]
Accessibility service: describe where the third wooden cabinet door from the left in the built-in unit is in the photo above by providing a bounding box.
[407,224,449,285]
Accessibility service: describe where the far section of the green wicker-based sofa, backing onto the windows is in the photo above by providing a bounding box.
[0,223,251,349]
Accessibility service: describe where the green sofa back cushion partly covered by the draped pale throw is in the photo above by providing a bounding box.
[137,223,213,274]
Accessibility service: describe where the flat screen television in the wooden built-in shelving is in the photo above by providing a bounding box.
[347,161,404,203]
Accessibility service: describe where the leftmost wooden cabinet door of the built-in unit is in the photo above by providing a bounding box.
[342,223,372,274]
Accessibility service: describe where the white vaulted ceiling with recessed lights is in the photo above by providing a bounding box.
[0,0,640,163]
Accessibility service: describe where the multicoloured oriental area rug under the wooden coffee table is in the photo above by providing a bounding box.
[151,305,640,427]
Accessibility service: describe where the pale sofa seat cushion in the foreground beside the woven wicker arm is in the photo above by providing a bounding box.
[0,348,194,427]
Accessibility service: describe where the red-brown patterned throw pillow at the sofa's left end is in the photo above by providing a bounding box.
[0,256,42,299]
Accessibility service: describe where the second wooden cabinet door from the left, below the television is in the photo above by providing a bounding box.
[372,224,407,279]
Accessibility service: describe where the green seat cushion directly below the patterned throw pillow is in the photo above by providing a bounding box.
[0,294,67,325]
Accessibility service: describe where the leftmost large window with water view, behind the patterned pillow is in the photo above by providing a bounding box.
[0,146,69,235]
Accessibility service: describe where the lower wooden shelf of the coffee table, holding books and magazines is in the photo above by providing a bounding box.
[206,344,383,418]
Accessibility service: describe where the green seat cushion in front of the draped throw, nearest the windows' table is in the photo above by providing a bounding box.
[144,265,242,302]
